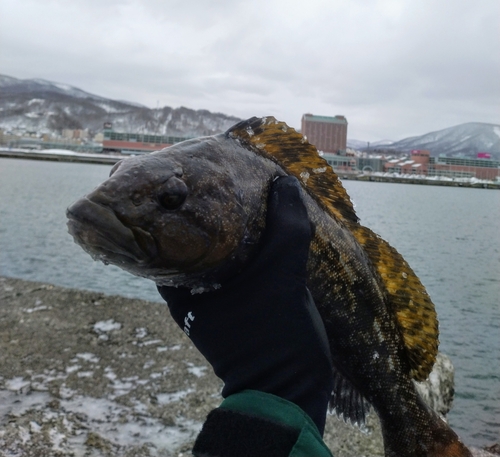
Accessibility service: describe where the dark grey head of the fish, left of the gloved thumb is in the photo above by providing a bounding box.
[67,136,271,286]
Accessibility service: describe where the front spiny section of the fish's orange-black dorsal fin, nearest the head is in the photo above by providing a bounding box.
[226,116,358,222]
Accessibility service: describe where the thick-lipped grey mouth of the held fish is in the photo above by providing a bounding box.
[66,198,158,266]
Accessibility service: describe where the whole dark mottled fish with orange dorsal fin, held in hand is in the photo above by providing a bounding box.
[67,116,471,457]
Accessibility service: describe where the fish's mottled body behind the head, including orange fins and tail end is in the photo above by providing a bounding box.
[230,117,470,456]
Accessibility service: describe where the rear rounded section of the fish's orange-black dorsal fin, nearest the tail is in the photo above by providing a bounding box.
[349,224,439,381]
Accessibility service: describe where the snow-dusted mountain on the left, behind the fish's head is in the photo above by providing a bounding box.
[0,75,240,136]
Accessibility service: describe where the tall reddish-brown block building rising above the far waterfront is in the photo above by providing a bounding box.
[302,114,347,154]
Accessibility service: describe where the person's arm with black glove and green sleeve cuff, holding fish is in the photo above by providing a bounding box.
[158,177,333,457]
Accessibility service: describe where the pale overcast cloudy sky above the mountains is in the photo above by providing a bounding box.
[0,0,500,141]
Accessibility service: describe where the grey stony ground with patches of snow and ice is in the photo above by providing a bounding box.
[0,277,492,457]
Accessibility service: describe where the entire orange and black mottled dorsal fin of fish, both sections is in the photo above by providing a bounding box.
[226,116,438,381]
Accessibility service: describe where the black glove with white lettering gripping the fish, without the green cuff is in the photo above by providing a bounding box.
[158,177,333,434]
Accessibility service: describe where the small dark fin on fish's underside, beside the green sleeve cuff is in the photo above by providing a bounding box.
[329,368,370,428]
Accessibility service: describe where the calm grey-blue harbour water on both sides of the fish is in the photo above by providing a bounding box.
[0,159,500,446]
